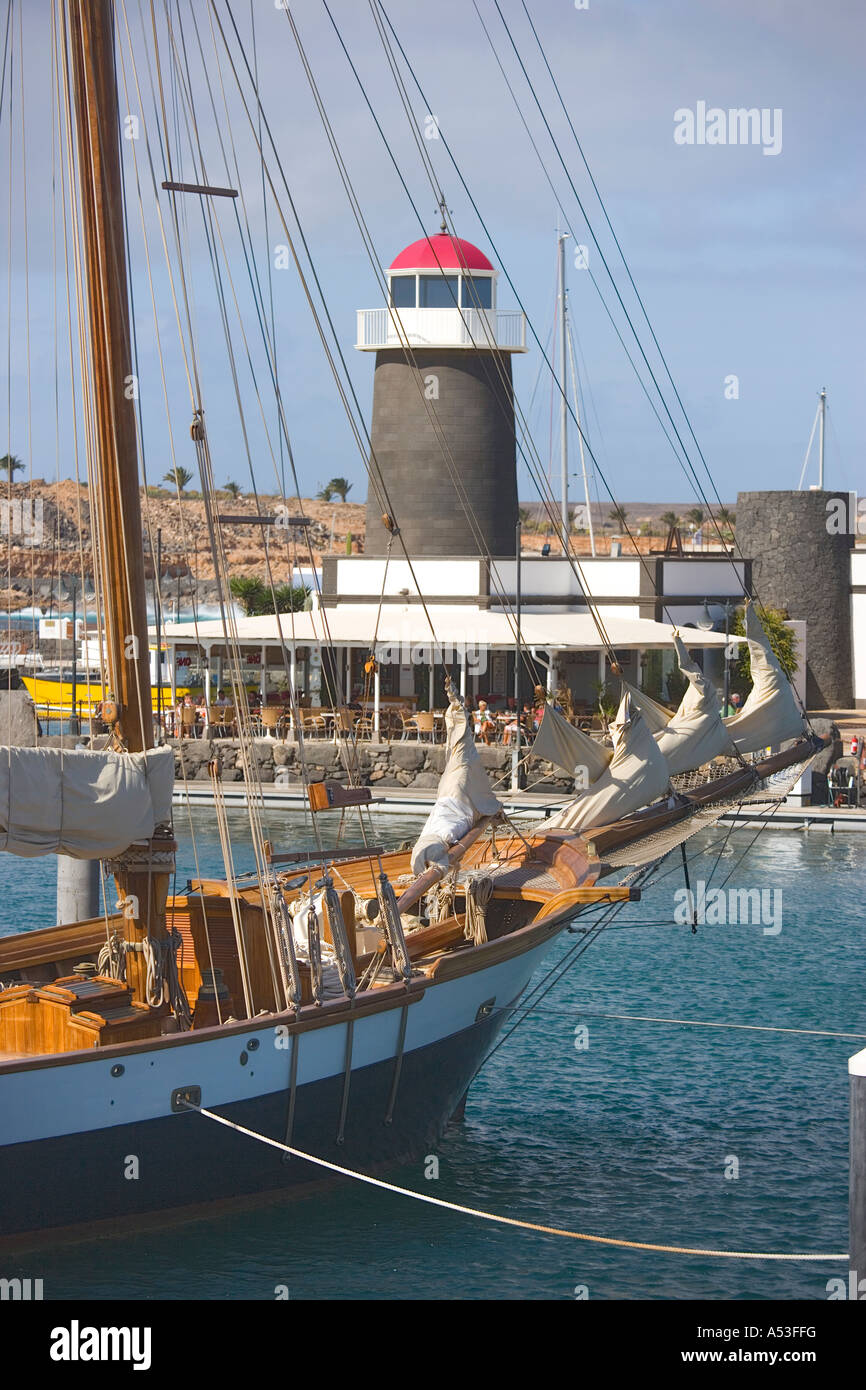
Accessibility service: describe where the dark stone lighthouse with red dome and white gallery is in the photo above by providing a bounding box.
[356,232,525,556]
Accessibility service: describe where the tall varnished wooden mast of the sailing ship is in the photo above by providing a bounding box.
[67,0,175,1001]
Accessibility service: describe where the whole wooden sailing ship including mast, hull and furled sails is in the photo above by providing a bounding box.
[0,0,816,1240]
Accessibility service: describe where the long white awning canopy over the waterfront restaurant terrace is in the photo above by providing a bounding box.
[157,603,737,662]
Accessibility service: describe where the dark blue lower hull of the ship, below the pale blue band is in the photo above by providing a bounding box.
[0,1011,507,1241]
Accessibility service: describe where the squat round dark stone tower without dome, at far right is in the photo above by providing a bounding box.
[737,492,853,709]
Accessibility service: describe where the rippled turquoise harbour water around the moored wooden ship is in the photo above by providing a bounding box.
[0,812,866,1300]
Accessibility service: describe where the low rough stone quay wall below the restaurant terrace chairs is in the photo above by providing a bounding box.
[172,738,573,792]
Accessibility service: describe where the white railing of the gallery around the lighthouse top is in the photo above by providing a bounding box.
[354,309,527,352]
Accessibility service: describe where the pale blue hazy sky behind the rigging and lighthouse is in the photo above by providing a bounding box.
[0,0,866,502]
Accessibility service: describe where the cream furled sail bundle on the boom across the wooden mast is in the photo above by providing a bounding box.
[0,748,174,859]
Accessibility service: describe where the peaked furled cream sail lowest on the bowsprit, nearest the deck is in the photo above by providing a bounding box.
[545,691,670,831]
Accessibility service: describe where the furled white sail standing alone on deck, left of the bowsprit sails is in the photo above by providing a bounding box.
[411,689,502,874]
